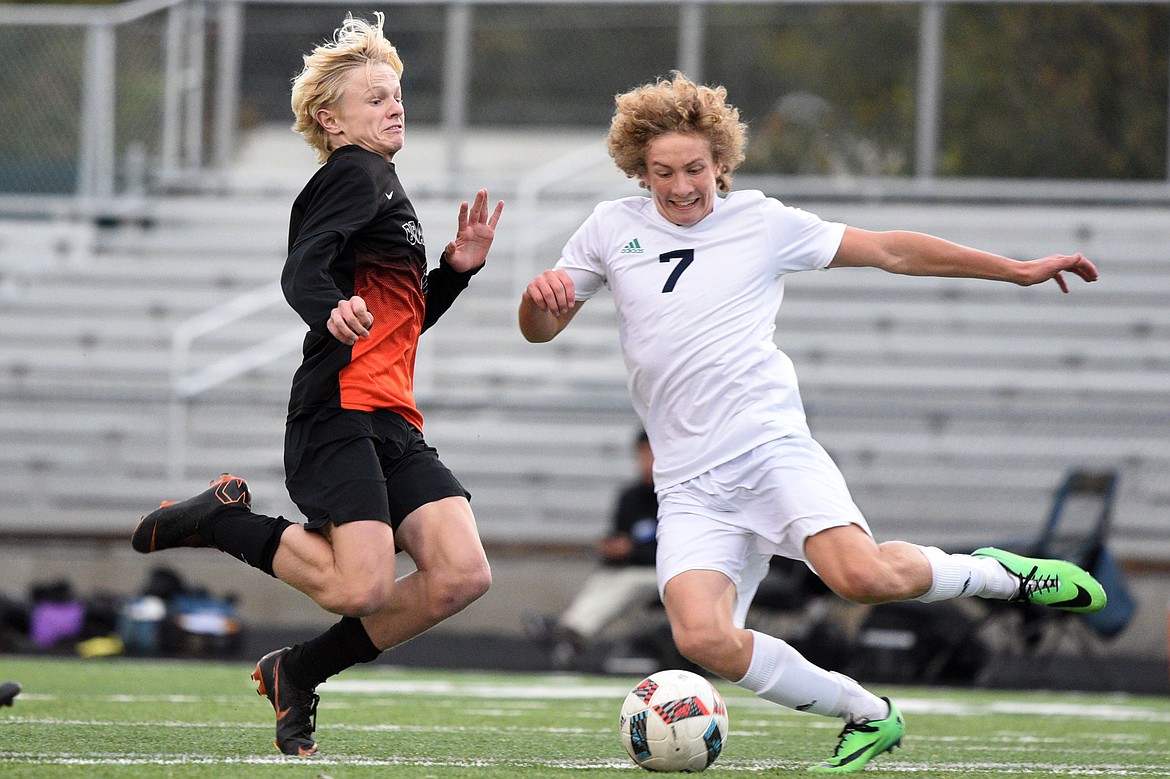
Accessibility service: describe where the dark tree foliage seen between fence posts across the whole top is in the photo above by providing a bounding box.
[0,0,1170,189]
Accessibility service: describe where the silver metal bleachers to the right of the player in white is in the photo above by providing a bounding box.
[777,204,1170,559]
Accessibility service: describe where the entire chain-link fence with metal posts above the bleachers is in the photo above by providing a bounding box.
[0,0,1170,206]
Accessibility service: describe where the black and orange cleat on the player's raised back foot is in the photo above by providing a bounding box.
[130,474,252,554]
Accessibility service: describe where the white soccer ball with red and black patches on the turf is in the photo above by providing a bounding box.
[620,670,728,772]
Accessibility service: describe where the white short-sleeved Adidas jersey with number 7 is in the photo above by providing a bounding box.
[557,191,845,490]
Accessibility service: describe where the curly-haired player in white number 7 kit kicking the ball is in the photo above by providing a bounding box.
[518,74,1106,773]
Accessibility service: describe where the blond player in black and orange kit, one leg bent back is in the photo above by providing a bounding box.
[132,13,503,756]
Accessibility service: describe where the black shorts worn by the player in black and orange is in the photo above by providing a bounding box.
[284,408,472,530]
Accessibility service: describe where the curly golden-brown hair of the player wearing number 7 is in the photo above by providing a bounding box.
[606,70,748,192]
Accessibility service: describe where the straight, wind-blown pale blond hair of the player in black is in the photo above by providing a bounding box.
[293,12,402,163]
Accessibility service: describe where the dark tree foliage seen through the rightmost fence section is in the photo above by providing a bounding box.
[940,5,1170,179]
